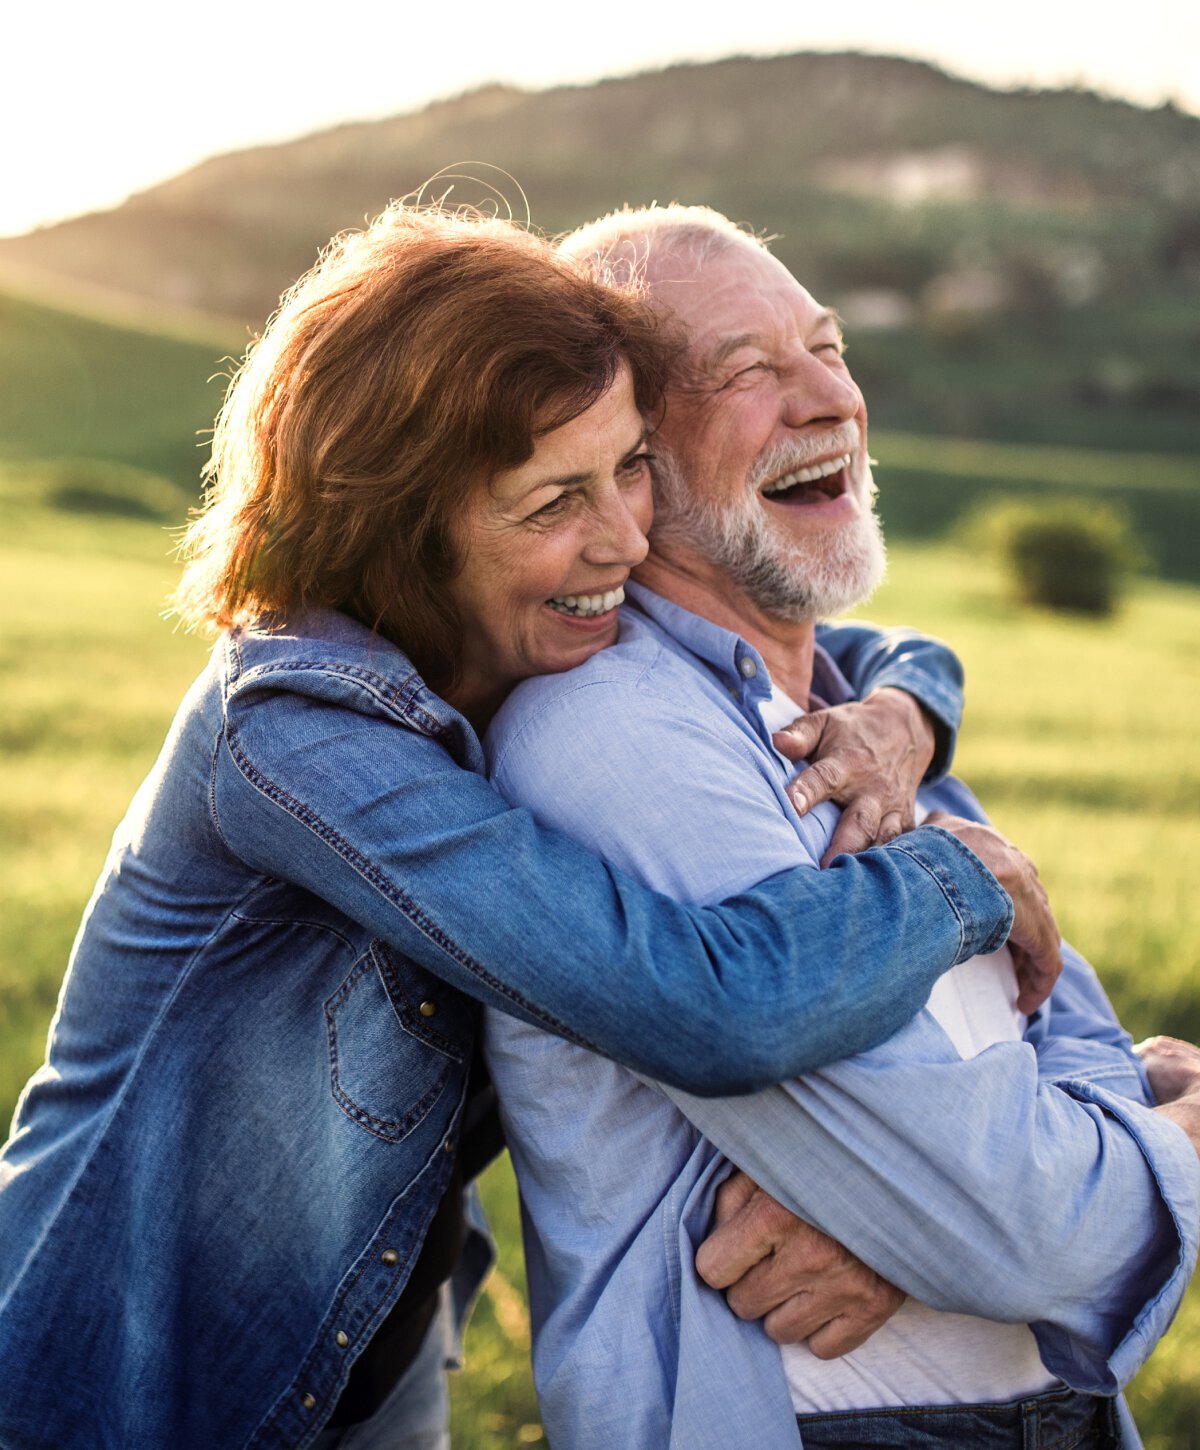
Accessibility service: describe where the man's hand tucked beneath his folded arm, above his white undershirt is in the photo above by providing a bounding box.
[696,1169,904,1359]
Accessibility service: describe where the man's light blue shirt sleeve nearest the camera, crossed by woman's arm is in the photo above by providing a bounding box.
[486,664,1200,1393]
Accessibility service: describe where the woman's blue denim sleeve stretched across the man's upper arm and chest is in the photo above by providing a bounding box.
[212,638,1012,1093]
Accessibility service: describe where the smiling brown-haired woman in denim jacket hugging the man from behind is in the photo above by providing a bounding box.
[0,207,1031,1450]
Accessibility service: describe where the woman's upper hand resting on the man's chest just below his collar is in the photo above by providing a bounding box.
[775,689,935,866]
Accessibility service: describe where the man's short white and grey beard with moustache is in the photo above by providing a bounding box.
[654,423,887,624]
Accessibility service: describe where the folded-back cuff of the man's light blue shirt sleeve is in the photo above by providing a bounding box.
[1032,1079,1200,1395]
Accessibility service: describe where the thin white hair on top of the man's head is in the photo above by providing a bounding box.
[558,202,768,294]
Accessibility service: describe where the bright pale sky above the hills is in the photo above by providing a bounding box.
[0,0,1200,235]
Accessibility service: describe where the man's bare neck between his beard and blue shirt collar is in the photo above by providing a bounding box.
[633,548,816,708]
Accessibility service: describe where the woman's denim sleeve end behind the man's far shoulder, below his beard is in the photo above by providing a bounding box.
[817,622,962,780]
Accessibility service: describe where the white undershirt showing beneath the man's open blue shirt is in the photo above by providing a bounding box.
[761,690,1058,1415]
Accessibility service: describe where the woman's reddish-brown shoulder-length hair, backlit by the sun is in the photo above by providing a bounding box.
[174,204,667,687]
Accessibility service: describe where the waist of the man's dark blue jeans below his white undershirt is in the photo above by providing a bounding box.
[797,1389,1128,1450]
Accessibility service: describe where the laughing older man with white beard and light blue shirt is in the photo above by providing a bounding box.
[487,209,1200,1450]
